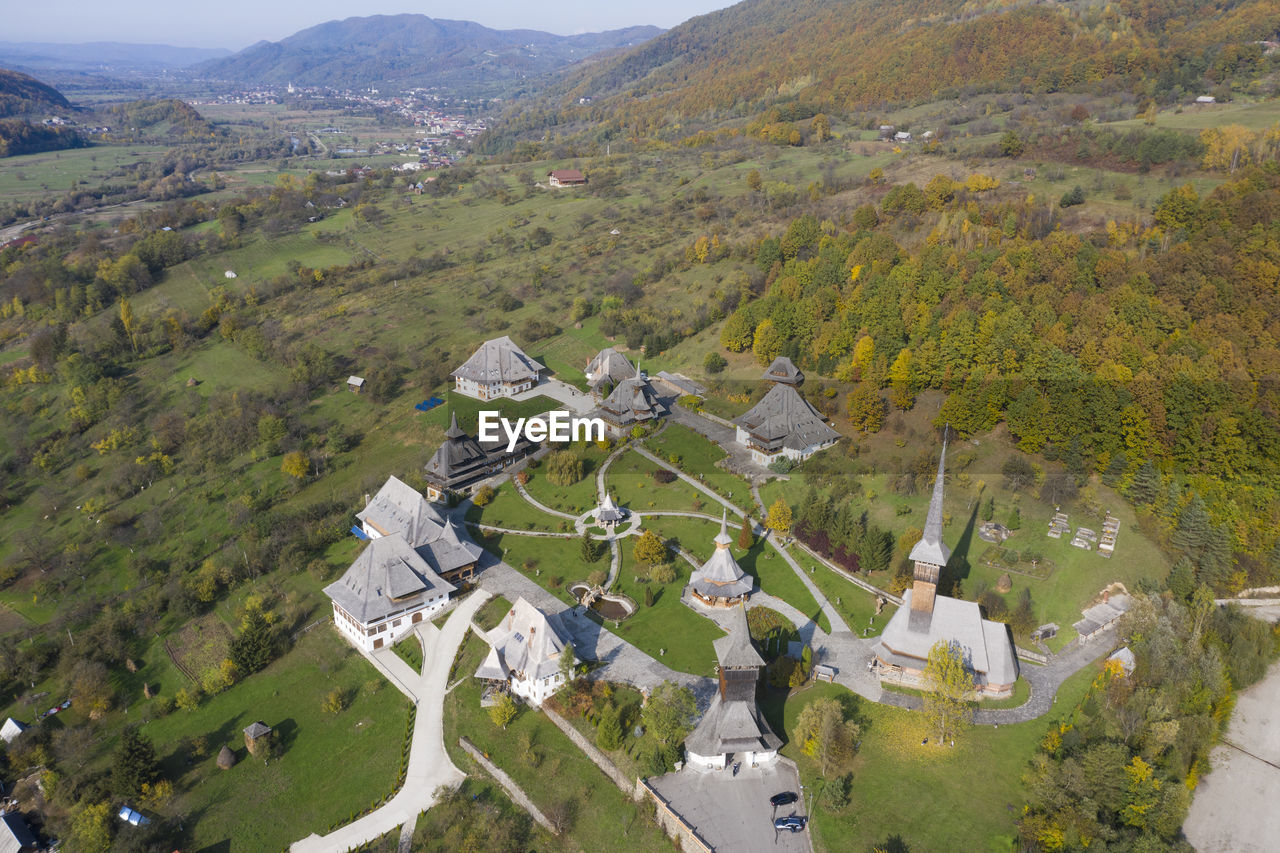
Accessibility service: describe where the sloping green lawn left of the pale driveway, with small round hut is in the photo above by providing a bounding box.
[143,626,408,850]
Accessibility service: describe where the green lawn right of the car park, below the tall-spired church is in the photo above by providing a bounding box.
[765,667,1096,853]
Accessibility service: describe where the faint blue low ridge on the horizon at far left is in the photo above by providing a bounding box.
[0,41,232,73]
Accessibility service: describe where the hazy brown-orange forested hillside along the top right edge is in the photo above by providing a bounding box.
[504,0,1280,134]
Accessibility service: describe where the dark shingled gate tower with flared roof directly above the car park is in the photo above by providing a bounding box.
[685,605,782,767]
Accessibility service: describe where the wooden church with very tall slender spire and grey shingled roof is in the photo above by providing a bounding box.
[876,441,1018,698]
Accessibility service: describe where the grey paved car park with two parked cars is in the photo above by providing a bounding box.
[649,758,813,853]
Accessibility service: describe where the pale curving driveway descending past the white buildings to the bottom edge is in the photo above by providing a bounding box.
[289,589,489,853]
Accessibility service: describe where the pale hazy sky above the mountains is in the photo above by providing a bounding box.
[0,0,735,50]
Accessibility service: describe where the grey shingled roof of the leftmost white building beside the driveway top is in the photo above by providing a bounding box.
[324,535,456,625]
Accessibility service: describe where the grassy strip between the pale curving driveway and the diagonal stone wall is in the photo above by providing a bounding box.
[444,633,671,853]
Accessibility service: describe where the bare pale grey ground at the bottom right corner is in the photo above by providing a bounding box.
[1183,650,1280,853]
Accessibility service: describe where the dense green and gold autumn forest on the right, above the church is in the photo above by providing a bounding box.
[721,164,1280,590]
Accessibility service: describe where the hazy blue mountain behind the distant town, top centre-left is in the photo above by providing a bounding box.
[191,14,663,95]
